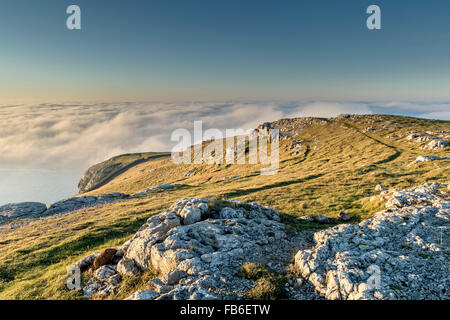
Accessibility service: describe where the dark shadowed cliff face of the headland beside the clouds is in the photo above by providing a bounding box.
[78,152,169,194]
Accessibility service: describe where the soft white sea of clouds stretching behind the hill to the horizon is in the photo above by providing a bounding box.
[0,102,450,205]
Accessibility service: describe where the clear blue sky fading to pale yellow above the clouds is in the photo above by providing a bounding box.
[0,0,450,104]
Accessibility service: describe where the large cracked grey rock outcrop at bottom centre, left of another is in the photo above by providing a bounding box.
[74,199,312,300]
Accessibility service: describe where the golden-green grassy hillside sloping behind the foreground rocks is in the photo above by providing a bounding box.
[0,115,450,299]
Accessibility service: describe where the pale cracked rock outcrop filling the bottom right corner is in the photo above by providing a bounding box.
[295,183,450,299]
